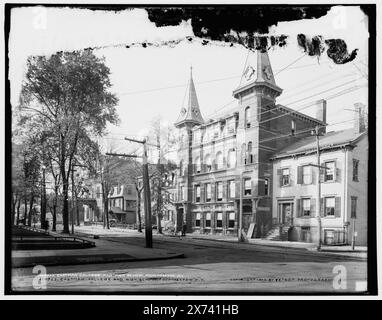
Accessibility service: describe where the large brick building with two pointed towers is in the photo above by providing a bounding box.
[175,51,326,237]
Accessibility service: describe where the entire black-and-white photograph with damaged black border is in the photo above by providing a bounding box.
[3,1,378,298]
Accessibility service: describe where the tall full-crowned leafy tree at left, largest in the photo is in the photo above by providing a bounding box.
[19,50,118,233]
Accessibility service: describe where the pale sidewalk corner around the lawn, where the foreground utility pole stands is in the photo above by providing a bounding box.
[12,226,184,268]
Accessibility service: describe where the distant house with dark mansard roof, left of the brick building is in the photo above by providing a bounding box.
[108,184,137,224]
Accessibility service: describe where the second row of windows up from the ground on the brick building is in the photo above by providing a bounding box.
[180,178,270,203]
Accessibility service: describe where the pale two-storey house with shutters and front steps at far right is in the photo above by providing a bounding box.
[268,104,368,245]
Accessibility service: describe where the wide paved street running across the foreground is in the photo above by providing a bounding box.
[13,233,367,293]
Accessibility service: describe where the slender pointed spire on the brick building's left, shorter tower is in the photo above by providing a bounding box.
[175,66,204,126]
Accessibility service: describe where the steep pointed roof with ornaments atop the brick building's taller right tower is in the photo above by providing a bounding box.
[233,50,282,98]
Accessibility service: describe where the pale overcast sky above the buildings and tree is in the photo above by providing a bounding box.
[9,6,368,158]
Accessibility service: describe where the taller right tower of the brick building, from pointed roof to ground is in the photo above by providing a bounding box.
[233,50,282,235]
